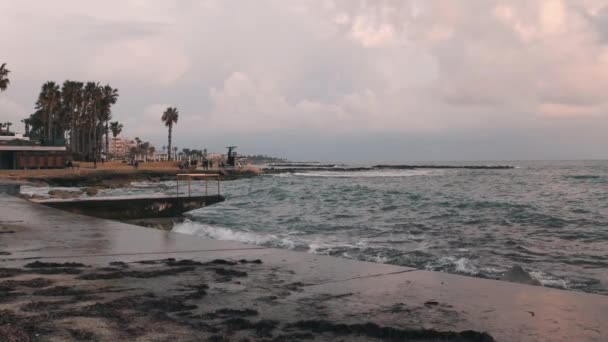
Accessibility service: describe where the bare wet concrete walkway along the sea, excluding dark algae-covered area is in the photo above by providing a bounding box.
[0,194,608,341]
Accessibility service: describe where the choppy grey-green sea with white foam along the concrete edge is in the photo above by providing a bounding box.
[22,161,608,295]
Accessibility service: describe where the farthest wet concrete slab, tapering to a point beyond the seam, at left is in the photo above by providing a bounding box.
[0,196,259,258]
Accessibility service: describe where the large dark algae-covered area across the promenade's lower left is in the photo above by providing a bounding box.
[0,259,493,342]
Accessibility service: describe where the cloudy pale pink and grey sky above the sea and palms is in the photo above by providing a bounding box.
[0,0,608,162]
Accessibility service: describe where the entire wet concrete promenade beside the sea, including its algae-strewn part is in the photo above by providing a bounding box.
[0,194,608,341]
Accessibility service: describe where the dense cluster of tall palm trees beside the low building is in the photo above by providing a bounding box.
[22,80,122,160]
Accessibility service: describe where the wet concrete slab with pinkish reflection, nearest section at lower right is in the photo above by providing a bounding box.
[295,271,608,342]
